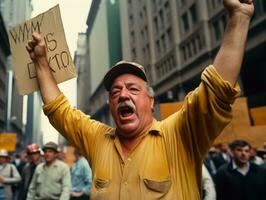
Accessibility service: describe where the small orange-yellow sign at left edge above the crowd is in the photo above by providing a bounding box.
[0,133,17,151]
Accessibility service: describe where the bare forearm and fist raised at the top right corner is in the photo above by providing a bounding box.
[214,0,254,86]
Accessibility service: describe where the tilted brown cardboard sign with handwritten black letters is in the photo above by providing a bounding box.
[8,5,76,95]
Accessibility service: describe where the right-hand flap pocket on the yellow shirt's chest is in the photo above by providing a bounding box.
[140,177,172,199]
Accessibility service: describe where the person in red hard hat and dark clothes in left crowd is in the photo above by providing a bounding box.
[17,143,42,200]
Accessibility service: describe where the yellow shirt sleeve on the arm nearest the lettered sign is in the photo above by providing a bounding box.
[43,93,112,162]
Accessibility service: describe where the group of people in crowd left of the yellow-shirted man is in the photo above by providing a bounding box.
[0,142,92,200]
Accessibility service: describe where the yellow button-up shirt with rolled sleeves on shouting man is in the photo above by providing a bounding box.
[44,66,239,200]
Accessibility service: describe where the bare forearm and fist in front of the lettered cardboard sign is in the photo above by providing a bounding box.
[26,32,60,104]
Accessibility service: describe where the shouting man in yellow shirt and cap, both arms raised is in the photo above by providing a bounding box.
[26,0,254,200]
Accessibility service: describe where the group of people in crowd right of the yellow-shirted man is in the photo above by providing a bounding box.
[202,140,266,200]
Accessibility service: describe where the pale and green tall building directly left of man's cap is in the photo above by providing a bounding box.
[81,0,122,124]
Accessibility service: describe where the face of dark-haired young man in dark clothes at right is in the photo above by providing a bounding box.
[232,146,250,165]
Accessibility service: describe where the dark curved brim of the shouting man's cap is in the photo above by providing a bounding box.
[103,63,147,91]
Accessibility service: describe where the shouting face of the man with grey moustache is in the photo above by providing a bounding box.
[109,74,154,138]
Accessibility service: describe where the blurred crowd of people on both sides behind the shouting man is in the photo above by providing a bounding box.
[0,140,266,200]
